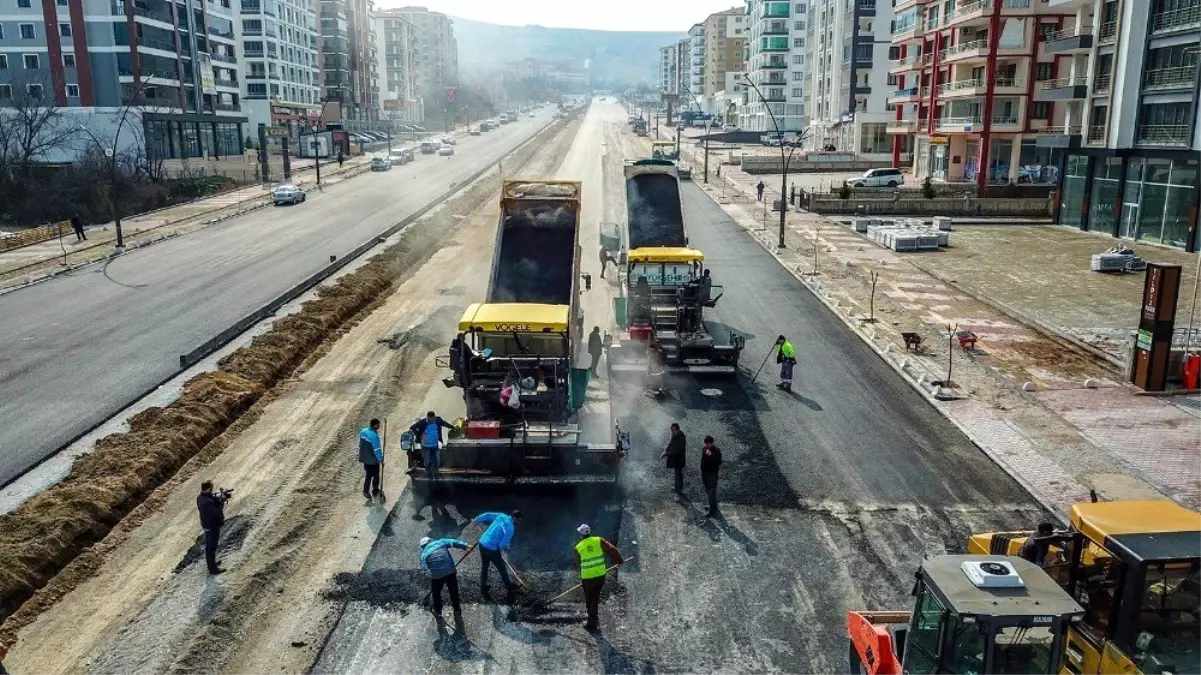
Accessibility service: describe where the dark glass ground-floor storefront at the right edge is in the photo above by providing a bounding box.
[1056,150,1201,251]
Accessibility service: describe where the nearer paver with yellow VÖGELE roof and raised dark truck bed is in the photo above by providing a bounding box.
[427,180,628,485]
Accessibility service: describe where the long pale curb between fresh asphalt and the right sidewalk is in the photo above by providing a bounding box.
[701,181,1066,525]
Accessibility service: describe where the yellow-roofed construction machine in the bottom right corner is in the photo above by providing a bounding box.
[968,494,1201,675]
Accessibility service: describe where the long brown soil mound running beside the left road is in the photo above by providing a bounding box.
[0,114,574,628]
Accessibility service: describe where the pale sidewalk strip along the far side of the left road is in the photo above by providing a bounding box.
[0,155,371,289]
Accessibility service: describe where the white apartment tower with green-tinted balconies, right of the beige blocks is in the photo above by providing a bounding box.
[739,0,807,132]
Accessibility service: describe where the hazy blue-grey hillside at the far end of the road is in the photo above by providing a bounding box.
[452,17,682,84]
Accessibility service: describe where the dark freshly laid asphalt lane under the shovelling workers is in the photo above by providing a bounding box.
[313,158,1042,675]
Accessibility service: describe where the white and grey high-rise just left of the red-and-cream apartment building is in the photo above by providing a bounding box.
[794,0,892,160]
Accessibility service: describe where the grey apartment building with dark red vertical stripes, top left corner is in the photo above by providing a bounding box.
[0,0,246,161]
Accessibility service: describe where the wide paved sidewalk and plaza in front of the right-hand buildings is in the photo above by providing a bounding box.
[685,136,1201,514]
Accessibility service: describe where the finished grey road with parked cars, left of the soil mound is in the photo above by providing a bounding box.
[0,110,551,485]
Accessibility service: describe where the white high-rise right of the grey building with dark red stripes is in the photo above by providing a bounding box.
[234,0,321,133]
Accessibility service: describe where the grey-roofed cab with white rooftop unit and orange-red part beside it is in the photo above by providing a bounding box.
[847,555,1090,675]
